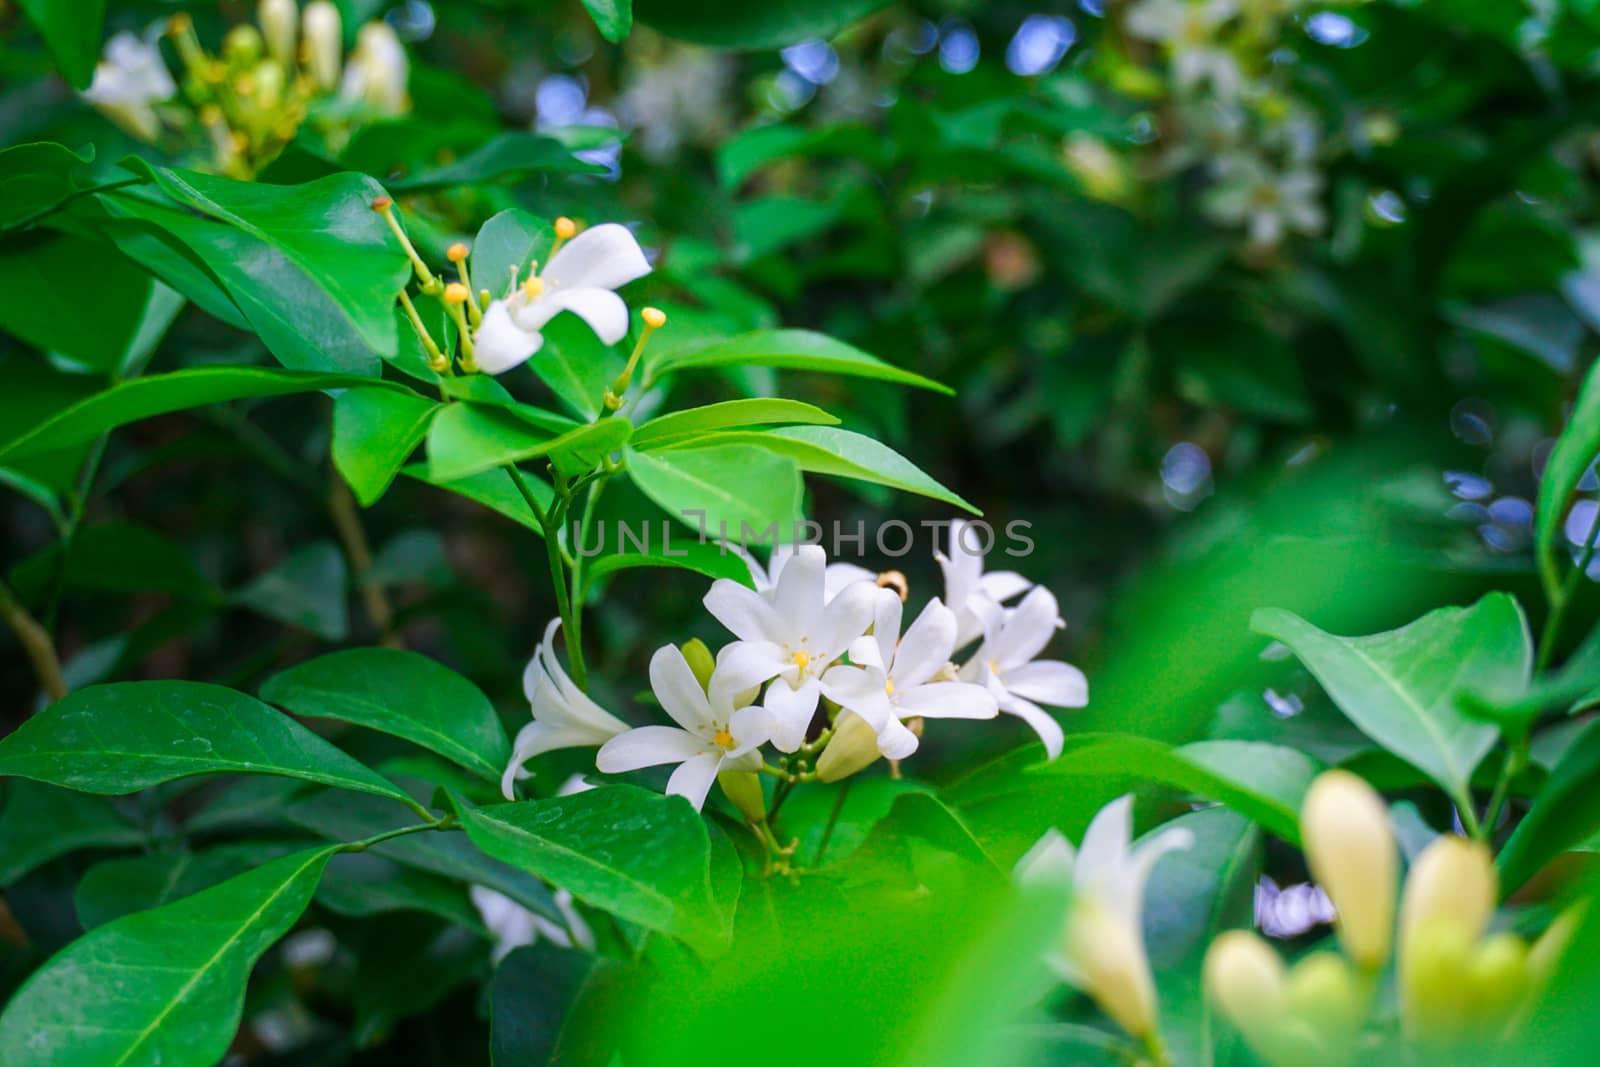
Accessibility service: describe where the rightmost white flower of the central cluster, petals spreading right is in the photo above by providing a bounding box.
[962,585,1090,760]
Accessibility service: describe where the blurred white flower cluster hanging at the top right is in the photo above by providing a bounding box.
[1125,0,1326,253]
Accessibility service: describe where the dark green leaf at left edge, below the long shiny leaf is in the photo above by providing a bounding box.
[0,779,144,888]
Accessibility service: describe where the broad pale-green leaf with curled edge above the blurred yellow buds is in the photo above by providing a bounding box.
[1251,593,1533,803]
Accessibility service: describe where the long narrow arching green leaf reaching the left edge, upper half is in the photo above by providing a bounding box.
[0,366,403,459]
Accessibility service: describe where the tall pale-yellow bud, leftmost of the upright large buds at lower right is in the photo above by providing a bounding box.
[1301,771,1400,969]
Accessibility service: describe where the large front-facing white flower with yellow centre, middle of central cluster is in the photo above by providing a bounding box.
[704,544,883,752]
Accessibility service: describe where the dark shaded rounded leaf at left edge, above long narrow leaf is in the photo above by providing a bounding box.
[0,231,150,373]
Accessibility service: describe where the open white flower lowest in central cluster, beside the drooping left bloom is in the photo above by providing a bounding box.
[595,645,773,811]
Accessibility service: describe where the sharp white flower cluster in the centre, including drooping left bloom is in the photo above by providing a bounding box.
[502,522,1088,808]
